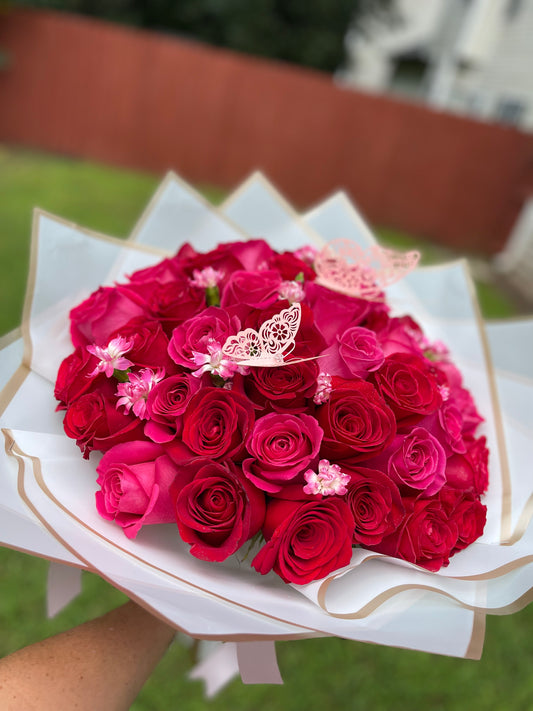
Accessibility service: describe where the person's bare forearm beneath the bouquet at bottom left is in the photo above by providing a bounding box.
[0,602,174,711]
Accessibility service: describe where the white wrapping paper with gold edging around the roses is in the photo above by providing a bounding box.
[0,175,533,658]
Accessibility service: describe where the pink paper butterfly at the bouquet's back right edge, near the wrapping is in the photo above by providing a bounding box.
[314,239,420,300]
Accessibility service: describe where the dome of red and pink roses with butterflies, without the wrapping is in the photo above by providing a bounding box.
[55,234,488,584]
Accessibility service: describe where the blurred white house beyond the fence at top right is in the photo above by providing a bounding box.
[342,0,533,130]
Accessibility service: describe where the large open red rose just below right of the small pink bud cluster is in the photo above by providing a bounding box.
[316,378,396,461]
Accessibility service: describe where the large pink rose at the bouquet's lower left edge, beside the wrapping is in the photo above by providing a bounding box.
[95,442,178,538]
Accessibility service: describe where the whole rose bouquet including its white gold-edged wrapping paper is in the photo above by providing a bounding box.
[0,175,533,682]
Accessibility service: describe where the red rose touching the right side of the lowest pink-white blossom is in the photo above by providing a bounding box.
[343,467,404,546]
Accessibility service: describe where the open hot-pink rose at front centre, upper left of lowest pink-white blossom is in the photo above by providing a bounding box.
[243,413,323,493]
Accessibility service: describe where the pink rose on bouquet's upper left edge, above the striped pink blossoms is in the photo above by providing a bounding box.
[70,286,146,346]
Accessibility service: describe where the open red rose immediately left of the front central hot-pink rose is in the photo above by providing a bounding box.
[182,387,254,461]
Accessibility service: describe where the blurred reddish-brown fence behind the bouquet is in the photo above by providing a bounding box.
[0,10,533,253]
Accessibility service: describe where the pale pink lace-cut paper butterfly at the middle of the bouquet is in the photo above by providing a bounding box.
[222,303,302,368]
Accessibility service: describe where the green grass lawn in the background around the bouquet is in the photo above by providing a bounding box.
[0,148,533,711]
